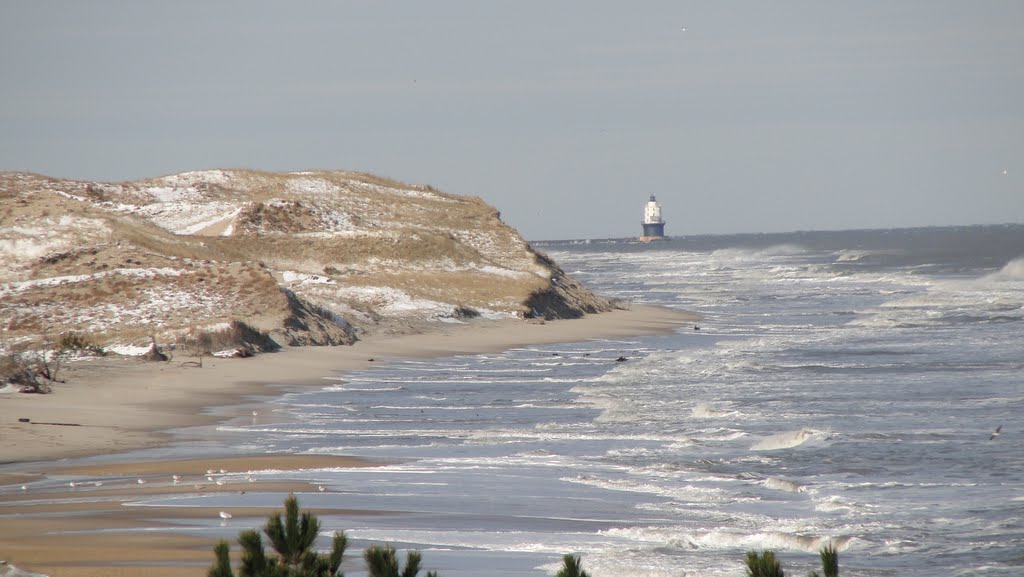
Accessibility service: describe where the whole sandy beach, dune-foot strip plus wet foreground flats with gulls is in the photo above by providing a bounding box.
[0,306,697,577]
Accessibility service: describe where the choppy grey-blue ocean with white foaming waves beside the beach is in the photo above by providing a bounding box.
[90,225,1024,577]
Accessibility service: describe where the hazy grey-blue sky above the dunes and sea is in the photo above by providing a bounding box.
[0,0,1024,240]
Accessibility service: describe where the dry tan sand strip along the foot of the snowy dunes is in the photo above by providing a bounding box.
[0,305,700,465]
